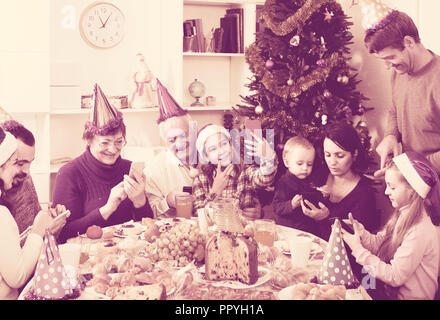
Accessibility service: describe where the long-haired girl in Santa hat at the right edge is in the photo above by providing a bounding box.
[343,152,440,300]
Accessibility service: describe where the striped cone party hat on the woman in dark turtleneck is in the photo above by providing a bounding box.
[86,83,123,136]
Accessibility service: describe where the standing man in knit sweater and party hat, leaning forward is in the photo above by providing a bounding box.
[362,0,440,175]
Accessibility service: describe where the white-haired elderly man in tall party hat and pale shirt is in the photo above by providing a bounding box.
[144,80,198,217]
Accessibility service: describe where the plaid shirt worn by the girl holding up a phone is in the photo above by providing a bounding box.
[193,157,278,212]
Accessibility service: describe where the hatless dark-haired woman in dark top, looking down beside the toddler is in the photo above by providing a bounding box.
[302,122,380,240]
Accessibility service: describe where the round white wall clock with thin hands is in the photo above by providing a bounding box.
[79,2,125,49]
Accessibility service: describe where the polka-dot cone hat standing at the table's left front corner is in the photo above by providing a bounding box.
[33,229,74,299]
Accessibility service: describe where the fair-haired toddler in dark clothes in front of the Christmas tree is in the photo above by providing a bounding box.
[273,136,319,235]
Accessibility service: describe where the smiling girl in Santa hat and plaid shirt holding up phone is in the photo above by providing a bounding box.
[193,124,277,218]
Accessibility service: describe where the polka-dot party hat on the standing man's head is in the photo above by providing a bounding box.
[360,0,397,33]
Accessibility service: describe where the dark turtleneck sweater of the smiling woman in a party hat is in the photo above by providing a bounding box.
[53,148,153,242]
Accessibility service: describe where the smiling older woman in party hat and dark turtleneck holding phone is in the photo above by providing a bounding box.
[53,85,153,242]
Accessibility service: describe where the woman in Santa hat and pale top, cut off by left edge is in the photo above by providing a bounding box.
[0,129,52,300]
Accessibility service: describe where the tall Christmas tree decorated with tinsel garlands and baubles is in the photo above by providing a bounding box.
[235,0,371,160]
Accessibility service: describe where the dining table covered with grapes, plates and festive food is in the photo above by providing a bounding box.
[19,217,371,300]
